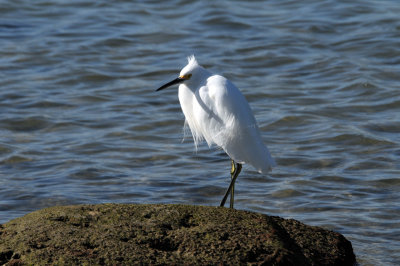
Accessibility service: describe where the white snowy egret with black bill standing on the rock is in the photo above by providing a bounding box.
[157,55,275,208]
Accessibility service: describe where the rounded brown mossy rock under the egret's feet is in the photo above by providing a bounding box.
[0,204,355,265]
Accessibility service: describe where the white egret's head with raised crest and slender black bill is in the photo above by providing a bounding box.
[156,55,205,91]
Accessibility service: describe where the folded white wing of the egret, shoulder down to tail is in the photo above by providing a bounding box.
[196,75,274,172]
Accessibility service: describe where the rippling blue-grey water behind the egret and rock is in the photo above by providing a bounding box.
[0,0,400,265]
